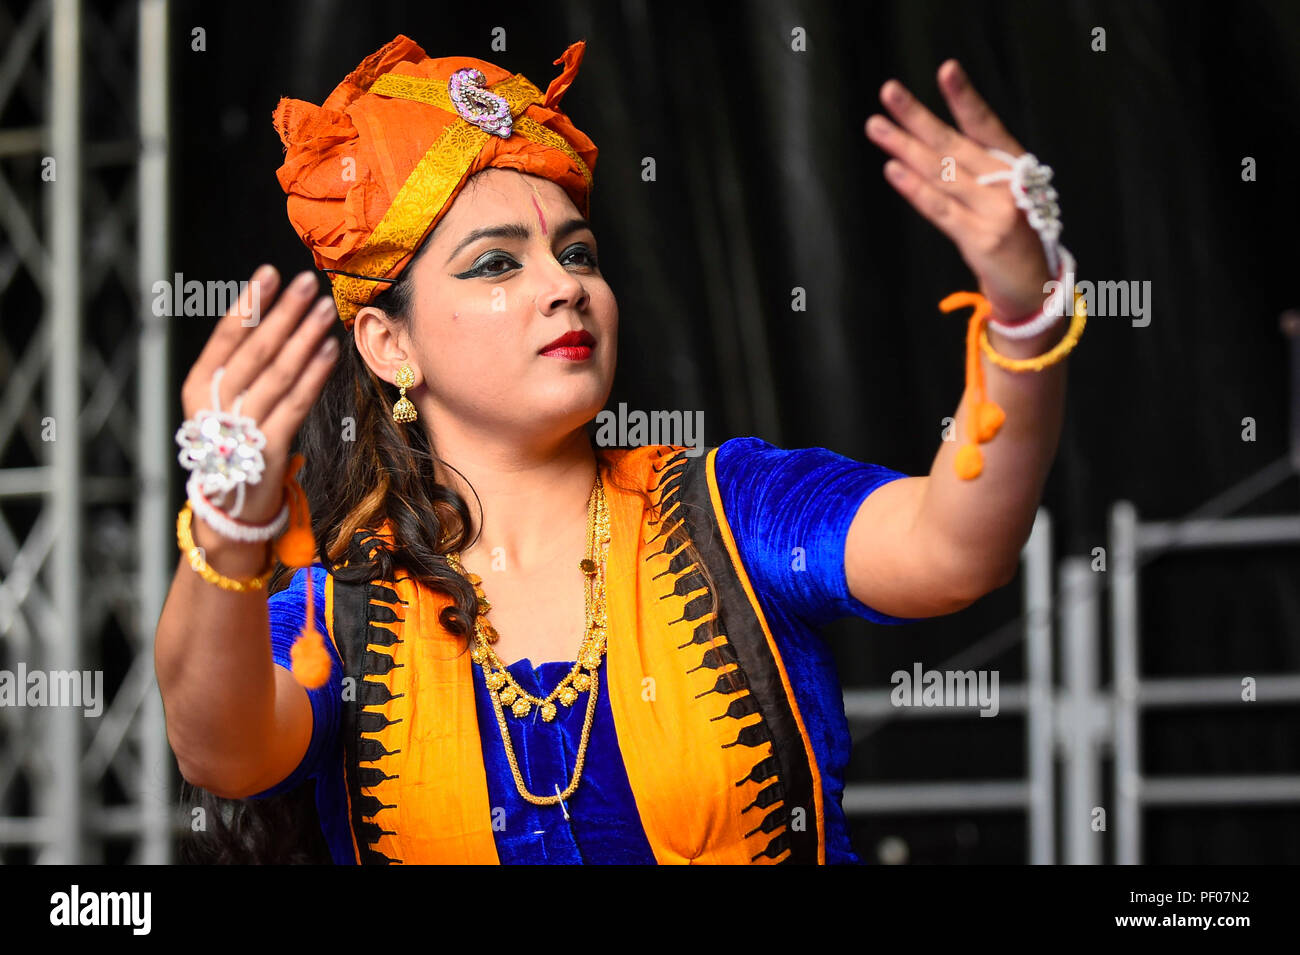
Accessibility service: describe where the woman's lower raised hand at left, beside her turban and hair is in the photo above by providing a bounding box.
[181,265,338,524]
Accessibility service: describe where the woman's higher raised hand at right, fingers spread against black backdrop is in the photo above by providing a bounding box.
[866,60,1056,321]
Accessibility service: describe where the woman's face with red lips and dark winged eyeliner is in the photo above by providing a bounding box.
[363,168,619,443]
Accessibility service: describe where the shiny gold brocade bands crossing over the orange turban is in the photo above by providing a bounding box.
[333,73,592,324]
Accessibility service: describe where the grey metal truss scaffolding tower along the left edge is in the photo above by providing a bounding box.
[0,0,177,863]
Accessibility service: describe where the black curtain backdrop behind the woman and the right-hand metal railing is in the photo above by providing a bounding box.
[167,0,1300,863]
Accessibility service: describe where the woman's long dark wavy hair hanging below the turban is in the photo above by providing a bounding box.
[179,177,716,864]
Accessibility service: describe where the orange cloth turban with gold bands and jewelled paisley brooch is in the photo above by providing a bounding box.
[274,36,597,326]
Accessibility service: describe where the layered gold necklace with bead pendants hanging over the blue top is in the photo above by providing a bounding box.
[447,470,610,806]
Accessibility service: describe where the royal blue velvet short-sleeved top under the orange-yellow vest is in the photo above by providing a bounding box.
[254,438,913,864]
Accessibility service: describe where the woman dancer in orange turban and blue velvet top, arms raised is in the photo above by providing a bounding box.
[156,36,1083,864]
